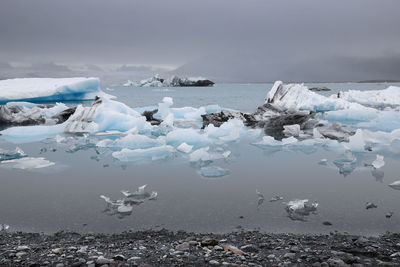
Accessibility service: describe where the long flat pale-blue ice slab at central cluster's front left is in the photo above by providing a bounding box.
[112,145,175,162]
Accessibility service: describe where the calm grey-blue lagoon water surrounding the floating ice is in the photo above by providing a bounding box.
[0,83,400,235]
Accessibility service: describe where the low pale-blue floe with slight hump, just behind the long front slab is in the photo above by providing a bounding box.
[96,134,165,149]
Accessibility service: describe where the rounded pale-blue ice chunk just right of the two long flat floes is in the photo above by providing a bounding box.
[166,128,210,147]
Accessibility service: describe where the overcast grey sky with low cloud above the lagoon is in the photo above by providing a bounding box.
[0,0,400,81]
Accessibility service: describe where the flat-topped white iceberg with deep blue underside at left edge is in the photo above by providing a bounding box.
[0,77,102,103]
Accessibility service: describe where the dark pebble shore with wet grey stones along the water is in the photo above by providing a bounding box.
[0,230,400,267]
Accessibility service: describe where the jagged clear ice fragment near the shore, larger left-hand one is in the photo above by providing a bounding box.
[100,185,158,218]
